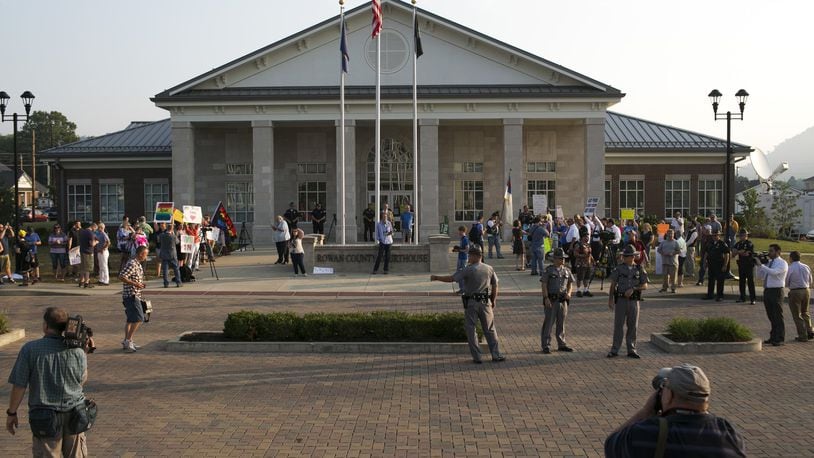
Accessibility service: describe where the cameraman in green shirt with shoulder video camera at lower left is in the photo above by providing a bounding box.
[6,307,93,457]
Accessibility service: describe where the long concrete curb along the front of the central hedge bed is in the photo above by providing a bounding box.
[165,331,489,358]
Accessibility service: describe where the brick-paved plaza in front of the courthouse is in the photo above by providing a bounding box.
[0,253,814,457]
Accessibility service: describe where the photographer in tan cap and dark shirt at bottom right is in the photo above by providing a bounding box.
[605,363,746,457]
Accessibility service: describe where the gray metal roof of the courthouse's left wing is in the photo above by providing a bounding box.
[40,119,172,158]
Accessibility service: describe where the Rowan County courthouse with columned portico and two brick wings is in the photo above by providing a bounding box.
[39,0,749,243]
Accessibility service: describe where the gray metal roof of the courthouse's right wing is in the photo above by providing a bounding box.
[605,111,751,153]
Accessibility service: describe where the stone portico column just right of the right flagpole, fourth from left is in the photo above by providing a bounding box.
[416,119,440,240]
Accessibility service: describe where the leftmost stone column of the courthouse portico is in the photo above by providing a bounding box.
[172,122,194,205]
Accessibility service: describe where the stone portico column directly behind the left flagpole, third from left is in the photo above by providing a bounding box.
[336,119,358,243]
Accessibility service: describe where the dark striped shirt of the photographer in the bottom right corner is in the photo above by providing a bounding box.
[605,414,746,458]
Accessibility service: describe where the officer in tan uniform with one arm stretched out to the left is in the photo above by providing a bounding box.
[430,245,506,364]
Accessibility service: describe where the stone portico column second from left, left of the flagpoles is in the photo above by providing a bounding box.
[251,121,274,246]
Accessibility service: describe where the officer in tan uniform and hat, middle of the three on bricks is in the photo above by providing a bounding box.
[540,248,576,354]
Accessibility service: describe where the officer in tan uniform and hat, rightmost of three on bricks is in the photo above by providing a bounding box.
[608,245,648,359]
